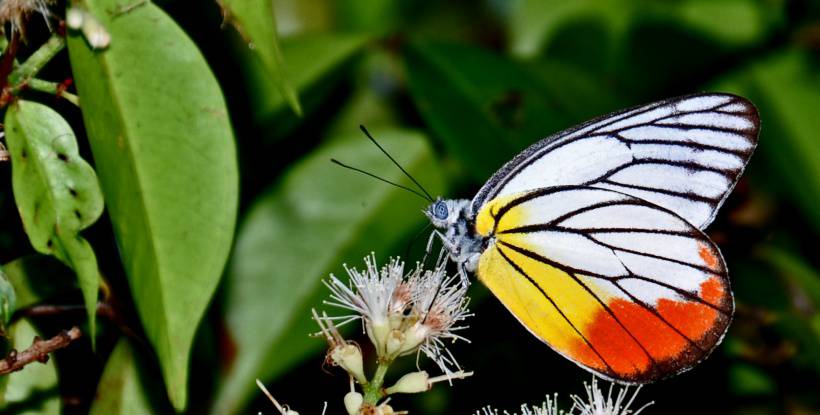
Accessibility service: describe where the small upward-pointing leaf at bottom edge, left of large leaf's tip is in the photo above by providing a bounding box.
[89,339,168,415]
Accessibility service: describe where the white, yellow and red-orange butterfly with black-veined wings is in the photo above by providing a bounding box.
[425,93,760,383]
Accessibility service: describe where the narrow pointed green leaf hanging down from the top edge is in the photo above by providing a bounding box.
[219,0,302,116]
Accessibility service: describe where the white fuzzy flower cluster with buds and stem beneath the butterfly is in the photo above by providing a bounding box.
[314,255,472,414]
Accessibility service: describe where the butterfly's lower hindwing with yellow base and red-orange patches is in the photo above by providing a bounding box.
[476,186,734,383]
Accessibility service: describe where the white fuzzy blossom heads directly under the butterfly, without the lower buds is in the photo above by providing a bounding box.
[320,254,471,375]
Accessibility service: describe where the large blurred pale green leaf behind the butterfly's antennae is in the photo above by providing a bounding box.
[212,130,443,414]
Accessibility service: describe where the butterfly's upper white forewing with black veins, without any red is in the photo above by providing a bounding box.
[472,94,760,229]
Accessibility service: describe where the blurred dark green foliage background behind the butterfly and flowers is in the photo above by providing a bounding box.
[0,0,820,414]
